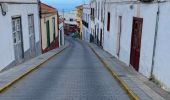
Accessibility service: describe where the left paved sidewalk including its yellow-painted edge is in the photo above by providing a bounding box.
[0,42,69,92]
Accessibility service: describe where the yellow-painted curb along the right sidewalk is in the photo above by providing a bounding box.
[88,43,140,100]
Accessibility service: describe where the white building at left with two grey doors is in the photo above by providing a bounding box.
[0,0,41,70]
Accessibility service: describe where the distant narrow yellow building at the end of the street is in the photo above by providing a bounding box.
[76,5,83,39]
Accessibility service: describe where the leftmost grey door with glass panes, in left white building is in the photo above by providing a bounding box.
[12,17,24,63]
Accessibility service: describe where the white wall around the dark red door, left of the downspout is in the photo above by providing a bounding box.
[104,4,157,77]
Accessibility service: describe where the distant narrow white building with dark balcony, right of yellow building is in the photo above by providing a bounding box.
[82,4,91,42]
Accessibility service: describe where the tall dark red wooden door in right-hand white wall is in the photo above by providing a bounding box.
[130,17,143,71]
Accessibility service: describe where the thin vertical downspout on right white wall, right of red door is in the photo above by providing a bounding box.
[150,0,160,80]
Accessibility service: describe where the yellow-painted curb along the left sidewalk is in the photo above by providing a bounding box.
[0,44,70,93]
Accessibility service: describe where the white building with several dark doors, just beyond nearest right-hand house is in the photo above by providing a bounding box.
[90,0,105,48]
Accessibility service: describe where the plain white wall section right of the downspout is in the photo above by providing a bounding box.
[153,2,170,91]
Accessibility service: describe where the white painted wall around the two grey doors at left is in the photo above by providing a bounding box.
[0,4,40,70]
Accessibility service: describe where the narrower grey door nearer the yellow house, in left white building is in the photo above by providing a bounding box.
[28,15,35,57]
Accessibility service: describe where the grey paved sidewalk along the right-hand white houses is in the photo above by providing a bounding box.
[89,43,170,100]
